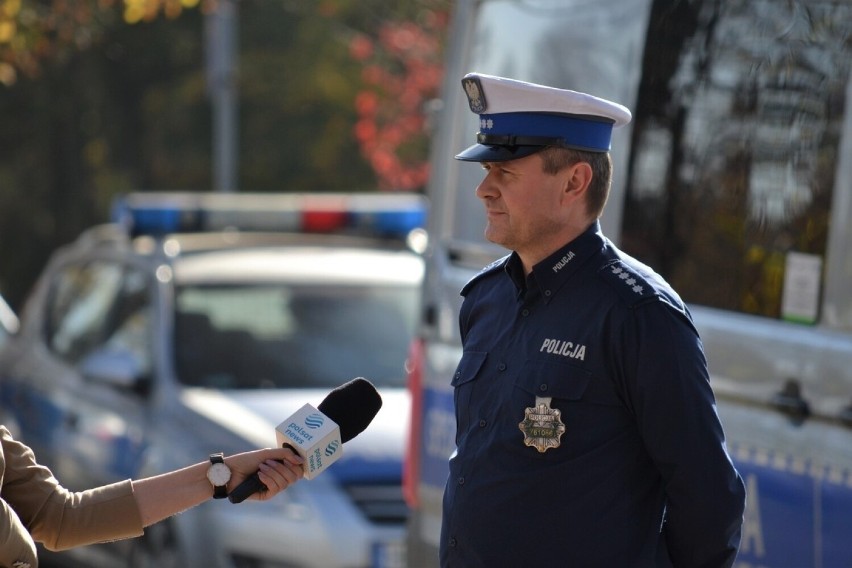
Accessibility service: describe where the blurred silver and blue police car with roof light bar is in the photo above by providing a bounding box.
[0,193,425,568]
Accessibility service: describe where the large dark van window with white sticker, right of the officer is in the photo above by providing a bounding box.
[622,2,852,323]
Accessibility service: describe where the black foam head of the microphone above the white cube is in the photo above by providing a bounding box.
[317,377,382,444]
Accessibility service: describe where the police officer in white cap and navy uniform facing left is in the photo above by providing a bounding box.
[440,74,745,568]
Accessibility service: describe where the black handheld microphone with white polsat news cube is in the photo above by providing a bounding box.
[228,377,382,503]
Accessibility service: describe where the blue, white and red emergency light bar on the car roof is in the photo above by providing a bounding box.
[112,192,426,238]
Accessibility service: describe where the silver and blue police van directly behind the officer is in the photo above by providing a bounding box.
[404,0,852,568]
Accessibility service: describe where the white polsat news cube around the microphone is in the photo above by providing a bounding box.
[275,404,343,479]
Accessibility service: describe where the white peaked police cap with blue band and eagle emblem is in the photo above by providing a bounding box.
[456,73,631,162]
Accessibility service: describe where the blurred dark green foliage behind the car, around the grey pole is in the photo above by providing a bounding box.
[0,0,450,310]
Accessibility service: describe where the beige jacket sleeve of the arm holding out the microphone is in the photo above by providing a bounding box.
[0,426,143,566]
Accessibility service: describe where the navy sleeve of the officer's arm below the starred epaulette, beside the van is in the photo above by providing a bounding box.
[621,301,745,567]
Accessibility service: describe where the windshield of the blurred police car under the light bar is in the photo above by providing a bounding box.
[174,283,419,389]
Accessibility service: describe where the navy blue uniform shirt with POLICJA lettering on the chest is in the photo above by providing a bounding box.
[440,223,745,568]
